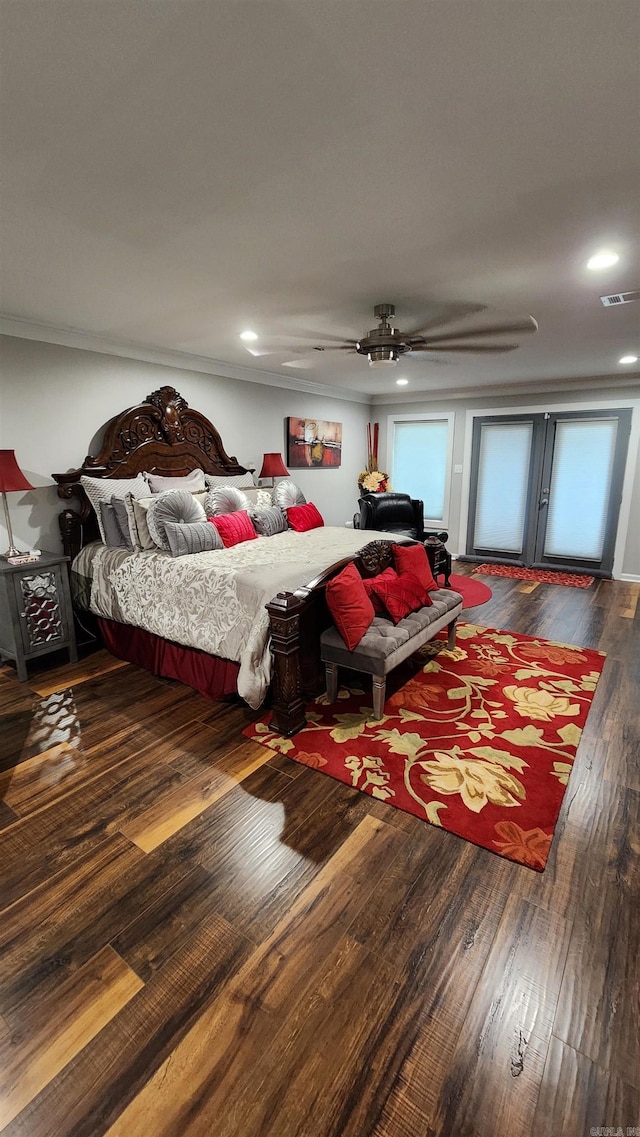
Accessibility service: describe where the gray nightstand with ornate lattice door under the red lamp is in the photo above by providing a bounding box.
[0,553,77,683]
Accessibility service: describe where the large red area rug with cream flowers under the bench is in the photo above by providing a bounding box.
[244,624,605,872]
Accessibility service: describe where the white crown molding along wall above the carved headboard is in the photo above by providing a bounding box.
[0,313,371,406]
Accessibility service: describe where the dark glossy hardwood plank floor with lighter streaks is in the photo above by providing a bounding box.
[0,564,640,1137]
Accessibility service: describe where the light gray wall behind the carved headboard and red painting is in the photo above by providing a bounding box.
[0,337,369,551]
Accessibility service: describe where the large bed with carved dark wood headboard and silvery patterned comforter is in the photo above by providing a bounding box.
[52,387,400,735]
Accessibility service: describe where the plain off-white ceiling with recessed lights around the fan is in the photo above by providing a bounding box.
[0,0,640,401]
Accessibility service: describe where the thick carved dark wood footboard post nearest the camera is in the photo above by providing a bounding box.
[267,592,307,735]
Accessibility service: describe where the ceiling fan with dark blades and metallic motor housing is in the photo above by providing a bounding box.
[306,304,538,367]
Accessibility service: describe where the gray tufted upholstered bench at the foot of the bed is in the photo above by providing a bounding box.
[321,588,463,719]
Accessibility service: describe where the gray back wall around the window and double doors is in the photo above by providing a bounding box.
[371,385,640,580]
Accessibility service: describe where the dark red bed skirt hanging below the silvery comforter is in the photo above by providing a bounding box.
[98,617,240,699]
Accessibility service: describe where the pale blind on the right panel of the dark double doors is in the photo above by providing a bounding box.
[545,418,617,561]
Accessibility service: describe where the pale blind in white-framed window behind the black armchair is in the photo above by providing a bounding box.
[390,418,449,522]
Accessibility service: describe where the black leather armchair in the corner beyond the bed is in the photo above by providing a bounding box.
[354,491,451,588]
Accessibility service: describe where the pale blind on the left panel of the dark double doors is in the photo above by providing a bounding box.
[473,422,533,553]
